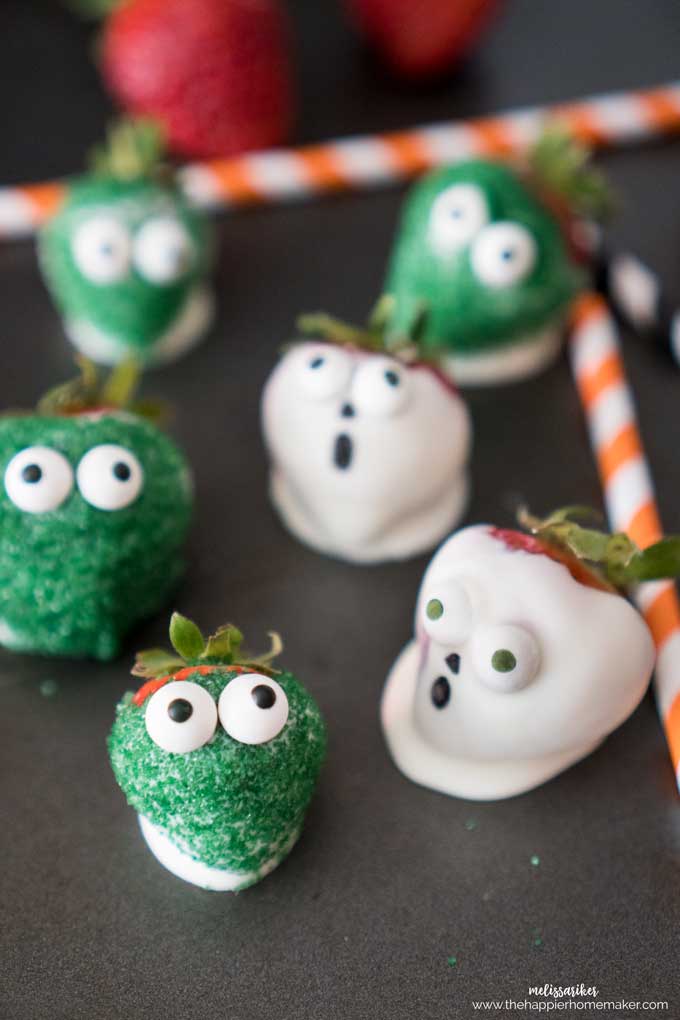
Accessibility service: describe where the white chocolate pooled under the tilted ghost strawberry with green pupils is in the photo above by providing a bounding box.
[380,642,601,801]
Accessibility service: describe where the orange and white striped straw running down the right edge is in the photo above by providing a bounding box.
[570,294,680,784]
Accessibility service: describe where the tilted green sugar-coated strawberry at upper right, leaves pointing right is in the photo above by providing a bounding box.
[385,129,609,385]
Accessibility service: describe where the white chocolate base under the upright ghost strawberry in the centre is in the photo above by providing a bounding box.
[269,467,470,563]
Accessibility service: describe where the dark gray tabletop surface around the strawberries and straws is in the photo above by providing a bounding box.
[0,0,680,1020]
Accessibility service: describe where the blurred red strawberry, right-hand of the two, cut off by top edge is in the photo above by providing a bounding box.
[348,0,498,78]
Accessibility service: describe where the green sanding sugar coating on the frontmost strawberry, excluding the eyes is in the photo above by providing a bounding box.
[108,666,326,872]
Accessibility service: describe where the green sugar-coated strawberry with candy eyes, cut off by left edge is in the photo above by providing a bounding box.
[0,365,193,659]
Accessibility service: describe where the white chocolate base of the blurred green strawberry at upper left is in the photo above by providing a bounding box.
[64,287,215,365]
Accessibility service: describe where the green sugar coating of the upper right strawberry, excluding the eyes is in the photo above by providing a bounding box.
[385,159,584,354]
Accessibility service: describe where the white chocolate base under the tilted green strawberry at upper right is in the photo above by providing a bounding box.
[440,320,564,387]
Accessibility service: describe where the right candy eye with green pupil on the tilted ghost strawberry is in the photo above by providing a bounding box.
[471,623,540,694]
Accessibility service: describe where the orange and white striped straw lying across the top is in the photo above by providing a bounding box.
[0,82,680,238]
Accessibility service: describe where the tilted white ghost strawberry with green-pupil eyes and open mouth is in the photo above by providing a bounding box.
[381,508,680,800]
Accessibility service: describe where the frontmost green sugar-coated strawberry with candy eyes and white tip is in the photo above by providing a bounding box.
[109,613,325,891]
